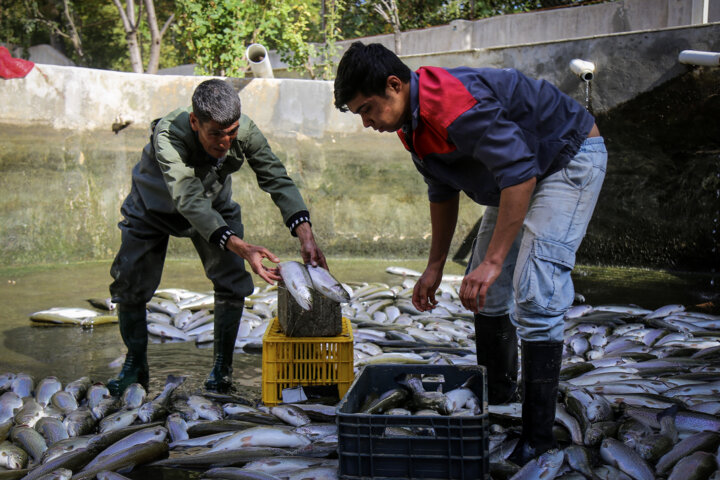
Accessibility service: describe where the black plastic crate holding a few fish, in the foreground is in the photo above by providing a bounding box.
[337,364,490,480]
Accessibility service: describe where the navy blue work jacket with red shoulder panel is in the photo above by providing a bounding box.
[397,67,595,206]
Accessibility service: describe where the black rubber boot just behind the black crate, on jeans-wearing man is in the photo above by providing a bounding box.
[475,313,518,405]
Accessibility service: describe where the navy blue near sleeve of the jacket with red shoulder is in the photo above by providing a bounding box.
[448,93,539,190]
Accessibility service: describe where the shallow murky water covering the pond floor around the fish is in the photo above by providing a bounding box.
[0,258,717,386]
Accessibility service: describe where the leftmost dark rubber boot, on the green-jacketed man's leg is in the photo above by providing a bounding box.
[107,305,150,396]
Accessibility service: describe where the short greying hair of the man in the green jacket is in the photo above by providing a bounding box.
[193,78,241,128]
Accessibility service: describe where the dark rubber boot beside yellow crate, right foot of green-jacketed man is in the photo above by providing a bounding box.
[205,300,243,393]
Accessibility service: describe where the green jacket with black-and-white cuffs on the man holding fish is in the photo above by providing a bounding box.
[133,107,309,244]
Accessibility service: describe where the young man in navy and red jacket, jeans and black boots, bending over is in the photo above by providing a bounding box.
[335,42,607,464]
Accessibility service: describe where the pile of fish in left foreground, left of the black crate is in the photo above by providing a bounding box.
[0,373,337,480]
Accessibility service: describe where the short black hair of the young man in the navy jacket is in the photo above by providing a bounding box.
[335,42,410,112]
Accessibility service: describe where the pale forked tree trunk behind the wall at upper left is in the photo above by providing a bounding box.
[113,0,175,73]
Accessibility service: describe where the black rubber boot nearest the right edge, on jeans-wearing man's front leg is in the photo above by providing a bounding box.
[508,340,563,467]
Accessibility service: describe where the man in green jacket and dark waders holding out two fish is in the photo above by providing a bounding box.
[108,79,327,395]
